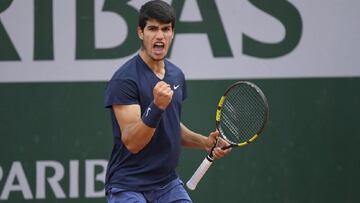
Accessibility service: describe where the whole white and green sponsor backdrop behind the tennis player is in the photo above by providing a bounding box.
[0,0,360,202]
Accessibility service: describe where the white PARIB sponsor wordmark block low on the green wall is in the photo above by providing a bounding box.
[0,159,108,202]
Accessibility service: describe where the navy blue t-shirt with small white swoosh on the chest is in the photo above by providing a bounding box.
[105,55,186,191]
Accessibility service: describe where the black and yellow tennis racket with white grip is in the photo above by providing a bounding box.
[186,81,269,190]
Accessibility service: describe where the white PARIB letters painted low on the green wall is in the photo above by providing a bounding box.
[0,159,108,200]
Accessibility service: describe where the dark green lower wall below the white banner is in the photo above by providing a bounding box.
[0,78,360,203]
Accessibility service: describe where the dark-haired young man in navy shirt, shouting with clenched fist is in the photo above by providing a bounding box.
[105,0,229,203]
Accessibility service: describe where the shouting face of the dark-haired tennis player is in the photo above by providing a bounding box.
[138,19,174,61]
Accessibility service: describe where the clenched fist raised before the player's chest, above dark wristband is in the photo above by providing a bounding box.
[153,81,174,110]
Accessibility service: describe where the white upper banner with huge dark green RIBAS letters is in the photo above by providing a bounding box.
[0,0,360,82]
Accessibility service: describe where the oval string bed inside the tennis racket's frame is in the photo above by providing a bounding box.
[220,85,266,143]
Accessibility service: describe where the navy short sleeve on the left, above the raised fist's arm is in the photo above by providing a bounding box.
[104,79,139,108]
